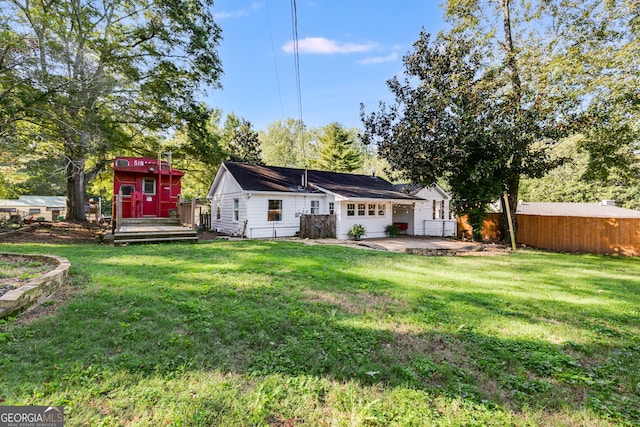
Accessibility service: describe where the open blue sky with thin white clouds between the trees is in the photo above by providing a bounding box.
[206,0,443,130]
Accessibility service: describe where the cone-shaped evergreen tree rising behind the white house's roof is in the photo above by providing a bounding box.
[312,123,363,172]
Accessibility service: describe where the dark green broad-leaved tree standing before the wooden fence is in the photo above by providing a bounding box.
[362,28,559,237]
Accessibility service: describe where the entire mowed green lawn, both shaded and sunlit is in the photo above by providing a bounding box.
[0,241,640,426]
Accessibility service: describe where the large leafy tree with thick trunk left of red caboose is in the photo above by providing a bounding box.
[0,0,221,220]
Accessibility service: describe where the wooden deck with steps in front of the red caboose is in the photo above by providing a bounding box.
[112,218,198,245]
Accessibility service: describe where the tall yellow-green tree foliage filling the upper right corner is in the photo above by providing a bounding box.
[444,0,640,227]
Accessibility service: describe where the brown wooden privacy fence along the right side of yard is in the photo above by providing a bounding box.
[458,214,640,256]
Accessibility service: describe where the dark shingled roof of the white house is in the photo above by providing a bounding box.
[223,162,420,200]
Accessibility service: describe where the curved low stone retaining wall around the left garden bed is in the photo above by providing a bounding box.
[0,253,71,319]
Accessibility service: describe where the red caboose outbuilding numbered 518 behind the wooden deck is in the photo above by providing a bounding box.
[113,157,184,218]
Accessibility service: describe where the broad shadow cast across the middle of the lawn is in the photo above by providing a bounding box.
[0,242,640,422]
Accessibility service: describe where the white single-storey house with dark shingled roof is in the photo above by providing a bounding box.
[208,162,456,239]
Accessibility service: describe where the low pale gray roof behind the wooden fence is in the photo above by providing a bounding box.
[516,202,640,218]
